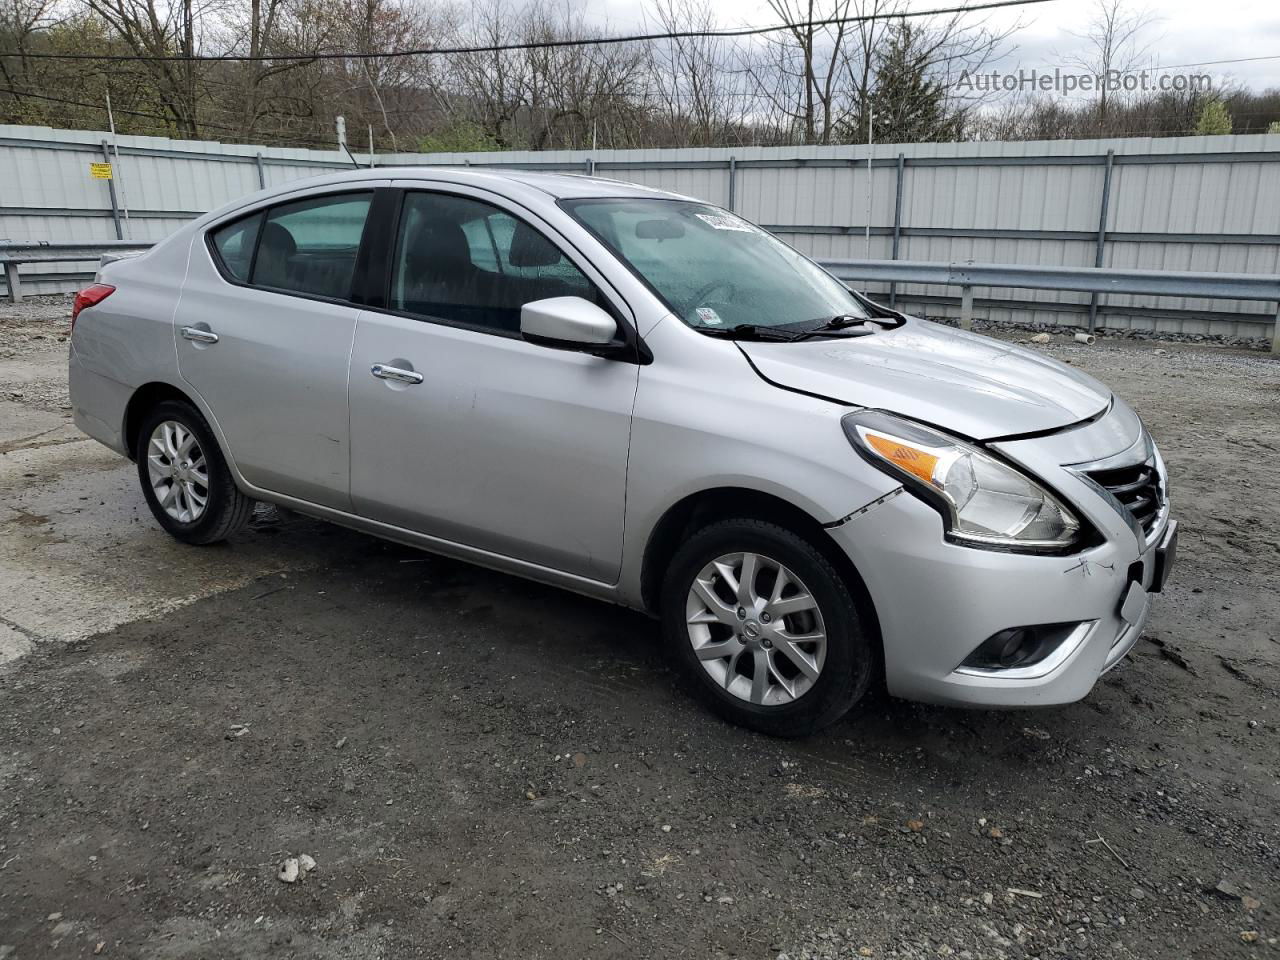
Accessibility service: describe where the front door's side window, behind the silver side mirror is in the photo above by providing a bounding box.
[390,193,600,335]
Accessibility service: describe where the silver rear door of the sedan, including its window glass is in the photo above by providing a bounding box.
[175,188,374,511]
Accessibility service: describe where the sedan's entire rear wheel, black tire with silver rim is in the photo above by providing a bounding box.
[134,401,253,544]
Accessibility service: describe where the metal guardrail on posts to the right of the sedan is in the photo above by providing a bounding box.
[818,260,1280,353]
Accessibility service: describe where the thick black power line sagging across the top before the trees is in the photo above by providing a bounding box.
[0,0,1053,63]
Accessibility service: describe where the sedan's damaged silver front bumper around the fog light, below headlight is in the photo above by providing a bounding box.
[828,396,1178,707]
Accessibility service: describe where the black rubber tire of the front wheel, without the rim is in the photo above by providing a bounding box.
[660,520,876,737]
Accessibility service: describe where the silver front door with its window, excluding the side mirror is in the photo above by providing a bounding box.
[351,191,639,582]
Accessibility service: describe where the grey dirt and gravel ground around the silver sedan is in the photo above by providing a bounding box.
[0,301,1280,960]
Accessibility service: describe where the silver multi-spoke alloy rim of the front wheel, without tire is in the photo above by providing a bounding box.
[685,553,827,707]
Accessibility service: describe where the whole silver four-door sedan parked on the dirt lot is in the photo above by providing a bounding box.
[70,169,1176,736]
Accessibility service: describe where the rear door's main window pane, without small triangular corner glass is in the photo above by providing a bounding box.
[245,193,372,300]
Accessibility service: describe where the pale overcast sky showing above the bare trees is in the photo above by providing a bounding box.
[588,0,1280,91]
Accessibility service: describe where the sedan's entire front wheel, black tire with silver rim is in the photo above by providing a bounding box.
[660,520,874,737]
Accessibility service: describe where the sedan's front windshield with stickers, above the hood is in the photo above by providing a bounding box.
[562,198,867,333]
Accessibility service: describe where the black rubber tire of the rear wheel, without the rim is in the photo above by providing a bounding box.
[133,401,253,545]
